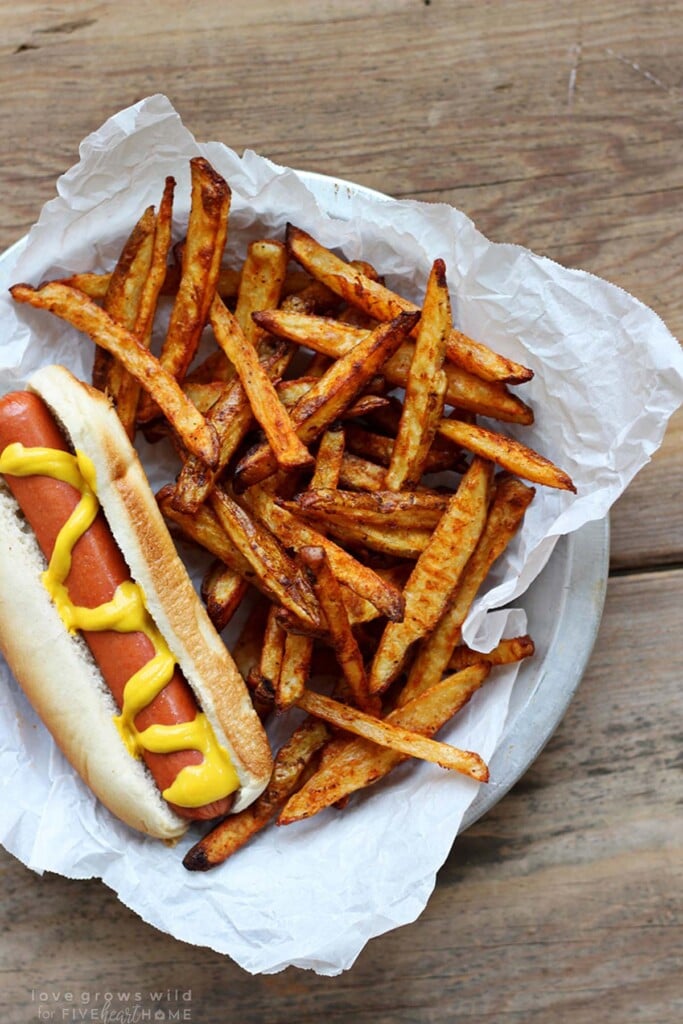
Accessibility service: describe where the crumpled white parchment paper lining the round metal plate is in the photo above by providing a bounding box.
[0,96,683,975]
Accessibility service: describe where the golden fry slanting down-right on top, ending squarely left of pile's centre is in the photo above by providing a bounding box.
[211,297,313,469]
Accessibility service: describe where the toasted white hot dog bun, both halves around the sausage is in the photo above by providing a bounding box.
[0,367,271,840]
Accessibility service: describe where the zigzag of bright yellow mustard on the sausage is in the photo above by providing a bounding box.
[0,443,240,808]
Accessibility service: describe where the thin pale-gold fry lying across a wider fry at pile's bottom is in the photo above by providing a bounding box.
[297,684,488,782]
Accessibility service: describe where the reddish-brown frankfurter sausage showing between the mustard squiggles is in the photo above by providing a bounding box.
[0,391,231,819]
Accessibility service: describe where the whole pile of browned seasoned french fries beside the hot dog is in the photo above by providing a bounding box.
[12,158,573,869]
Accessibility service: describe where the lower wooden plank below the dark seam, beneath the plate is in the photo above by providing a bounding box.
[0,572,683,1024]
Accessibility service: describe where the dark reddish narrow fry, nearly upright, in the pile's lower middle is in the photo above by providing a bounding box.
[299,547,380,715]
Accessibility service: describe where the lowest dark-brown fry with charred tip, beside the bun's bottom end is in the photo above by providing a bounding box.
[182,718,330,871]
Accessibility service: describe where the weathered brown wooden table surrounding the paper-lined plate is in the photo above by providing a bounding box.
[0,0,683,1024]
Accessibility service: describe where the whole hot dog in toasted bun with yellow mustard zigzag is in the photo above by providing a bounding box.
[0,367,270,839]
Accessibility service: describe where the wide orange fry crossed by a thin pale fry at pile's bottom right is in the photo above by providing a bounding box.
[278,665,490,824]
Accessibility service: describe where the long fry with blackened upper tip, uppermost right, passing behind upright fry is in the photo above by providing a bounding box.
[287,224,533,384]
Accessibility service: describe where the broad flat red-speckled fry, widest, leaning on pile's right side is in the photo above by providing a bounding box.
[370,459,493,693]
